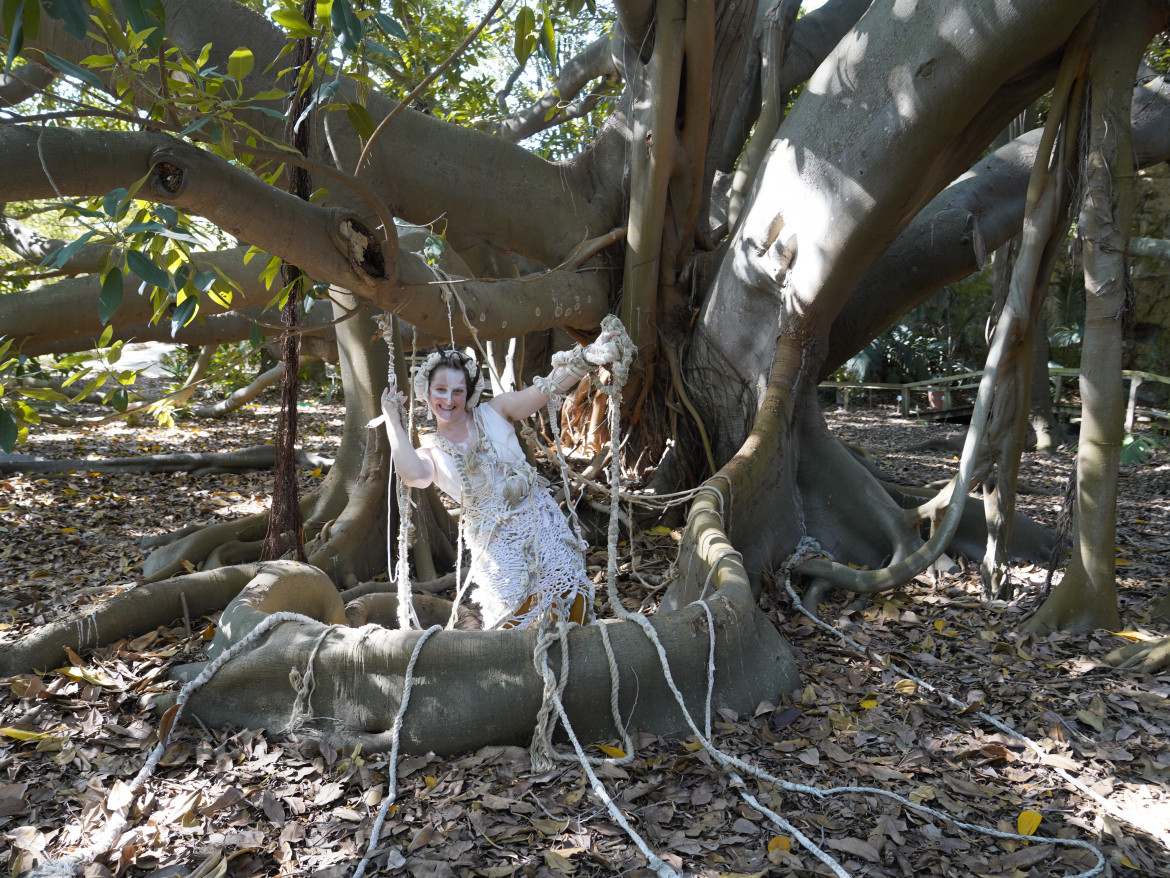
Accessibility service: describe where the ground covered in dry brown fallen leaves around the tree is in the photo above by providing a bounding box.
[0,402,1170,878]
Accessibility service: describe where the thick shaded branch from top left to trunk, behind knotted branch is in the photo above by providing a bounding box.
[11,0,622,276]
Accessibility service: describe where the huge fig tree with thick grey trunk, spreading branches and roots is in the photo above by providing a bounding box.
[0,0,1170,752]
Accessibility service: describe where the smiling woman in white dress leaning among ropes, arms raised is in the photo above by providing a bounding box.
[381,331,619,629]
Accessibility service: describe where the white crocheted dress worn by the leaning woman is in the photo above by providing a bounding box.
[419,404,592,629]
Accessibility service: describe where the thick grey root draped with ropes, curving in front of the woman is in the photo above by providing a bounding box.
[162,561,797,754]
